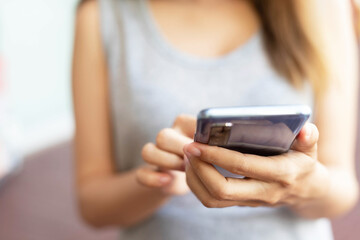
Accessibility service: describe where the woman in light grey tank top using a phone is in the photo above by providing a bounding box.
[73,0,358,239]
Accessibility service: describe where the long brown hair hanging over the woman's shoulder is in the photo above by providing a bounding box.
[253,0,328,97]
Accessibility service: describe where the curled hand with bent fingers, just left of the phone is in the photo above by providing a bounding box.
[136,115,196,195]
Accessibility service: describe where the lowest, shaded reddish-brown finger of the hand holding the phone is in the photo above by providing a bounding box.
[186,158,237,208]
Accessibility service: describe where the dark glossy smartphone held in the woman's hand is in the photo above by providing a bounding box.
[194,105,311,178]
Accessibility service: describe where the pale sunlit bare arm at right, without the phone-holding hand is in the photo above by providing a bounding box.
[296,0,359,217]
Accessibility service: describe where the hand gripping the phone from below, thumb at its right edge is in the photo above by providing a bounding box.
[184,123,330,208]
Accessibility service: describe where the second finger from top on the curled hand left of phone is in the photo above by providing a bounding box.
[156,128,193,157]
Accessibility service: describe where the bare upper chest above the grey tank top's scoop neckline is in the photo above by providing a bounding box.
[147,0,259,58]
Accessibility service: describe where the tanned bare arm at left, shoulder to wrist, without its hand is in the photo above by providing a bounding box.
[73,1,168,227]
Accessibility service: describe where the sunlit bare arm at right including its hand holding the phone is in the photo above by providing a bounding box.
[184,0,359,218]
